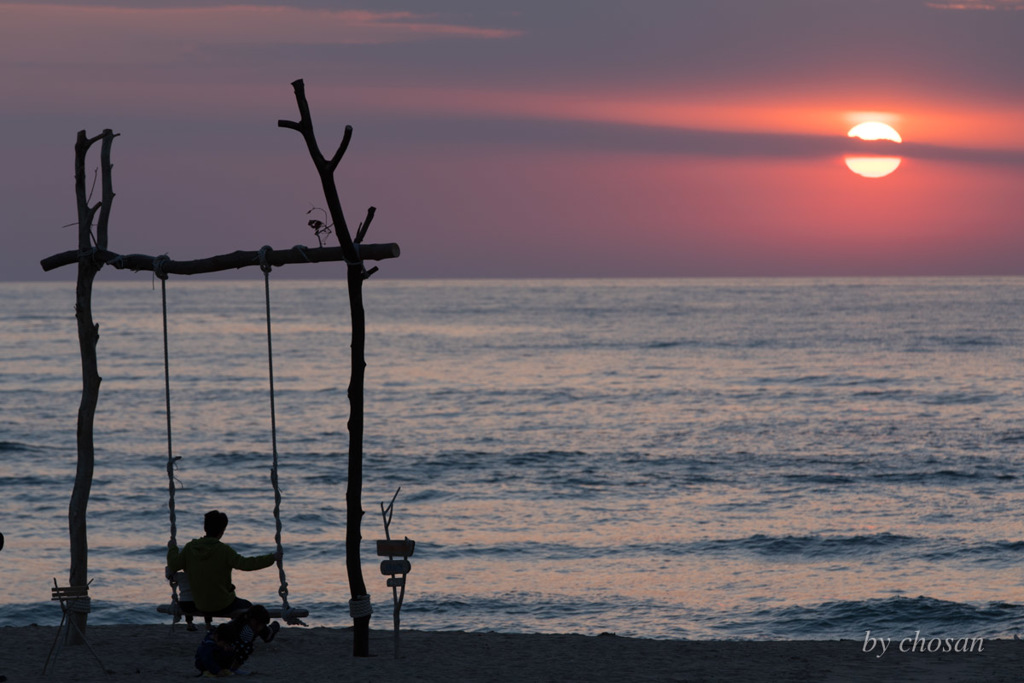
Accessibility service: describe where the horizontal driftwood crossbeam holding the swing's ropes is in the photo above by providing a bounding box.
[40,244,400,275]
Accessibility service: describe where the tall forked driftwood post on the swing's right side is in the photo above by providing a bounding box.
[278,79,395,656]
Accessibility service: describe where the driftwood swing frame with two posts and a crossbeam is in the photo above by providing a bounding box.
[41,79,400,656]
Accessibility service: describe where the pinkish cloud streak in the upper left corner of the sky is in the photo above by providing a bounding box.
[0,3,519,65]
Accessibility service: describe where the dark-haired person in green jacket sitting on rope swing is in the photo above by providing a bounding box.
[167,510,278,625]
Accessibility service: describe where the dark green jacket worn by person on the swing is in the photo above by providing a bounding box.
[167,536,276,612]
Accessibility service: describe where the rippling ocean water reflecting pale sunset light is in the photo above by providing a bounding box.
[0,278,1024,639]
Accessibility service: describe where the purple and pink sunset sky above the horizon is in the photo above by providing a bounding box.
[0,0,1024,281]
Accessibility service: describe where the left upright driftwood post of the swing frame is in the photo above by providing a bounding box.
[68,129,115,644]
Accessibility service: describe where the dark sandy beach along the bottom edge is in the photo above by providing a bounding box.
[0,625,1024,683]
